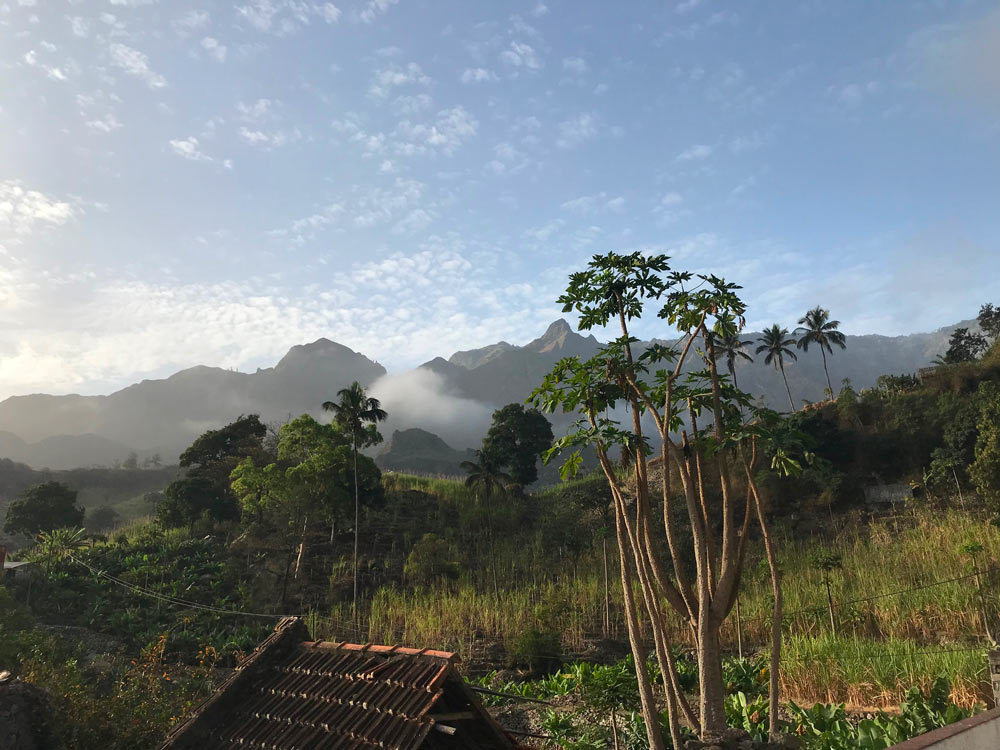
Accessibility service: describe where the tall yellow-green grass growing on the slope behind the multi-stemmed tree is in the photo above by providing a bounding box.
[358,475,1000,707]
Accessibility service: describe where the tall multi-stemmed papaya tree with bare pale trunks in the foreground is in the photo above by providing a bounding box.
[531,252,791,750]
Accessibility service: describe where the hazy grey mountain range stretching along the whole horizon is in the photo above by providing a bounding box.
[0,320,975,469]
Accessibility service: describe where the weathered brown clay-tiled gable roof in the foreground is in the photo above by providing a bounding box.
[160,617,517,750]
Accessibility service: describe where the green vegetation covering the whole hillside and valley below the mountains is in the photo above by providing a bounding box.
[0,296,1000,750]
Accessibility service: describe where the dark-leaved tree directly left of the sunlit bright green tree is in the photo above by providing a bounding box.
[156,414,267,528]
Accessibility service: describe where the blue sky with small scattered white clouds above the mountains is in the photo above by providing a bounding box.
[0,0,1000,398]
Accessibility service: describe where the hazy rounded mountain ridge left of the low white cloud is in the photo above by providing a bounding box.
[0,339,385,469]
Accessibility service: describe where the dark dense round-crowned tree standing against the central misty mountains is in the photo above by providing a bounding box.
[480,404,552,487]
